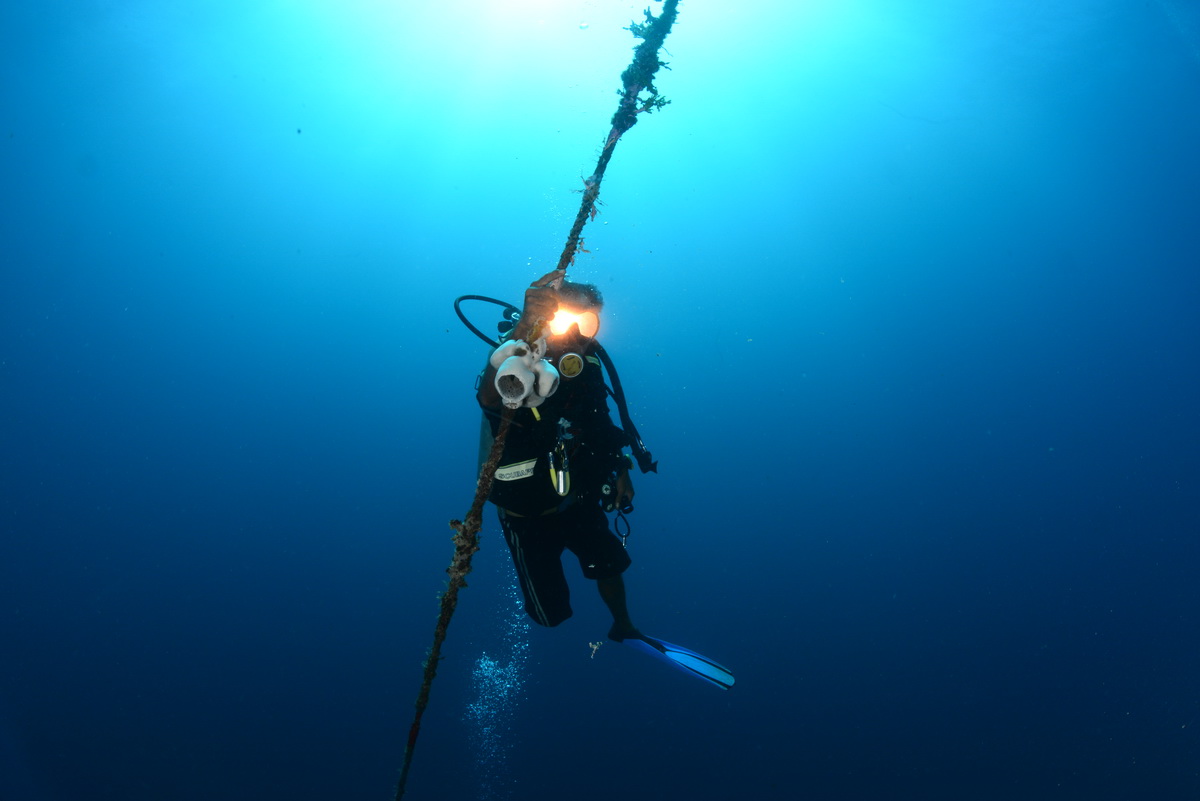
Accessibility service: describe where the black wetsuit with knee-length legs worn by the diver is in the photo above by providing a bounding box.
[484,338,630,626]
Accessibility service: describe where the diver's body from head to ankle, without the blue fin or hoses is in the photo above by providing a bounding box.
[476,282,638,642]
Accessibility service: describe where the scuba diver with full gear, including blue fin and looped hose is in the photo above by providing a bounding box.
[465,281,733,689]
